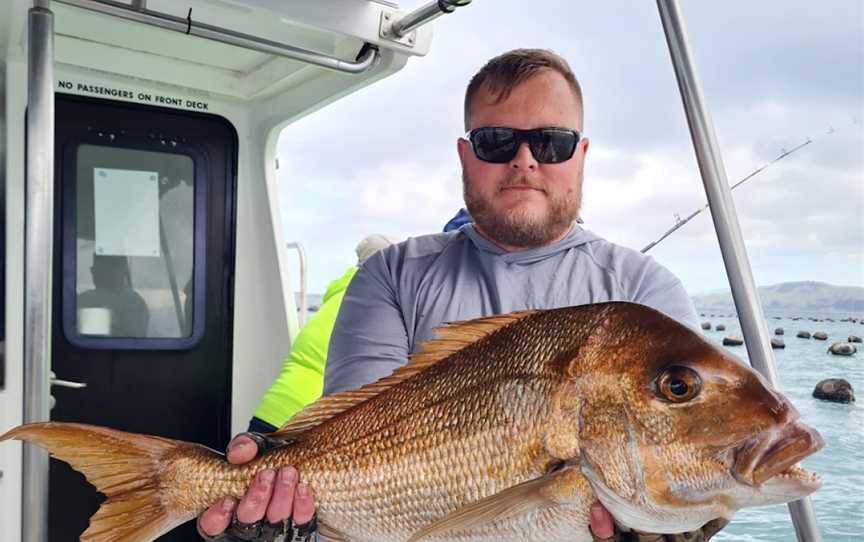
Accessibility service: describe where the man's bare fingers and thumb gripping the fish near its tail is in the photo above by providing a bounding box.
[198,433,315,540]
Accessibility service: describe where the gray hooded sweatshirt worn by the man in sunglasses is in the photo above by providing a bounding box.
[324,224,698,395]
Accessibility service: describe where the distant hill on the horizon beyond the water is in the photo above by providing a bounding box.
[693,281,864,312]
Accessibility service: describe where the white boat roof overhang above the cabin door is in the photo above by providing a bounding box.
[0,0,431,117]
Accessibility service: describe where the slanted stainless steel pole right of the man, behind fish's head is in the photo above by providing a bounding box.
[657,0,822,542]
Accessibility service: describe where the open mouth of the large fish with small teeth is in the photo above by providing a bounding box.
[733,420,825,486]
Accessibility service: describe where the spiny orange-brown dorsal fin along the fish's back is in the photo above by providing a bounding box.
[273,310,537,438]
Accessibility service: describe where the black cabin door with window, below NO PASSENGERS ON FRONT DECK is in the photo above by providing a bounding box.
[49,95,237,542]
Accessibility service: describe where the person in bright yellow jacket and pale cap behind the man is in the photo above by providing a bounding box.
[249,234,395,433]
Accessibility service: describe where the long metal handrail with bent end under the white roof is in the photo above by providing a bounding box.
[56,0,379,74]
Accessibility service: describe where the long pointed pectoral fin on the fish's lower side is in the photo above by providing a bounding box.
[408,471,564,542]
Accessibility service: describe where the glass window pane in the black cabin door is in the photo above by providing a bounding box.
[64,144,203,348]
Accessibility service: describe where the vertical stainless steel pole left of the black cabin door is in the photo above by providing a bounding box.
[22,1,54,542]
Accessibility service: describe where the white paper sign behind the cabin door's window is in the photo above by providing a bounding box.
[93,168,160,256]
